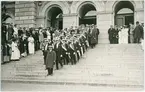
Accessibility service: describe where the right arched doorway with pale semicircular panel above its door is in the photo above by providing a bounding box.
[114,1,134,27]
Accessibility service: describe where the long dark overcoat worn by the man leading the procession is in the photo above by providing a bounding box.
[46,51,56,68]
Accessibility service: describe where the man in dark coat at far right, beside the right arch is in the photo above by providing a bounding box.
[134,21,143,43]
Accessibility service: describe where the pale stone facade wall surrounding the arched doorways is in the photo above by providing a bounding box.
[12,1,144,43]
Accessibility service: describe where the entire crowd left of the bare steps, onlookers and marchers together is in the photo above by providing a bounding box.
[1,23,99,75]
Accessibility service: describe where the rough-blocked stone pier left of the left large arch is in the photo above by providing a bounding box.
[15,1,36,27]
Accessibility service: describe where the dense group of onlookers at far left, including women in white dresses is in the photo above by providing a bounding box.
[1,23,40,63]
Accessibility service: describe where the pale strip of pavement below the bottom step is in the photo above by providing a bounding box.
[2,83,142,92]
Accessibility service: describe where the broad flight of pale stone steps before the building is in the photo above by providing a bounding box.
[1,44,144,90]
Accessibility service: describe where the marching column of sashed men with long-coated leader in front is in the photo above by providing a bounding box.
[42,25,99,75]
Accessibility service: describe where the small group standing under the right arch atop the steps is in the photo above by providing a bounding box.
[108,21,144,44]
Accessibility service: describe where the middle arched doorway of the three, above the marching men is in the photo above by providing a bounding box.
[79,3,96,25]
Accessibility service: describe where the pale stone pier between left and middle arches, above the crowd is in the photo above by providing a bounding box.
[63,14,79,28]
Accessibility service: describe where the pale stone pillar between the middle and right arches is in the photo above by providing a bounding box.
[97,12,113,43]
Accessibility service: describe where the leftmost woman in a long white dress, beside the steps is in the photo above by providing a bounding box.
[11,39,20,60]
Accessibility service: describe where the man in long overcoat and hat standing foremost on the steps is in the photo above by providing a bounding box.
[45,45,56,76]
